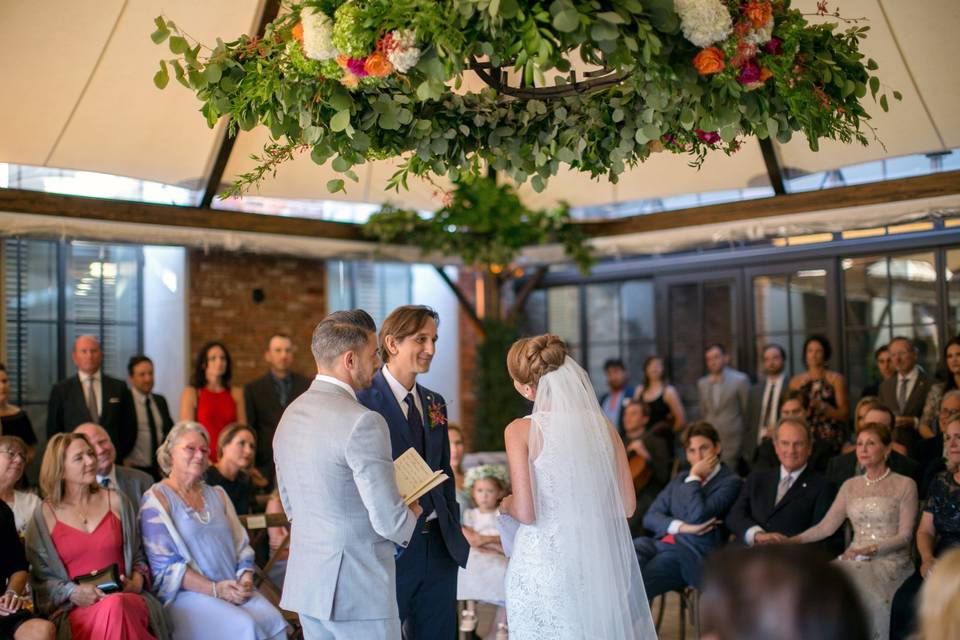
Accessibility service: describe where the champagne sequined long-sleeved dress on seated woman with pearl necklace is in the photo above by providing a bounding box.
[797,472,917,640]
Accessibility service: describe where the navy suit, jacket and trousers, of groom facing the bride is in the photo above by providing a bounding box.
[357,371,470,640]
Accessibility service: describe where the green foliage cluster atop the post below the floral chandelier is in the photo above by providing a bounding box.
[363,178,593,273]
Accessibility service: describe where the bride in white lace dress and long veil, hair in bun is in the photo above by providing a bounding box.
[500,334,656,640]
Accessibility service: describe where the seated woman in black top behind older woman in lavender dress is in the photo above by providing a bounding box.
[206,422,258,515]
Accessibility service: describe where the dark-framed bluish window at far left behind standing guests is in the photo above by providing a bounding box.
[3,239,143,437]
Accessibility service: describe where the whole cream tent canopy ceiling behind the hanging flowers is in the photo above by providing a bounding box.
[0,0,960,245]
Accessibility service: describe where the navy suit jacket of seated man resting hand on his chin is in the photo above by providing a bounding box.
[643,463,742,557]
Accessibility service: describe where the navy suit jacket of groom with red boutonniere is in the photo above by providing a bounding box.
[357,371,470,567]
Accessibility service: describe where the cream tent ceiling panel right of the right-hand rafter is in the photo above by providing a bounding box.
[779,0,960,173]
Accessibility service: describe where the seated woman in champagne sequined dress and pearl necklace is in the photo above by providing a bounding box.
[789,422,917,638]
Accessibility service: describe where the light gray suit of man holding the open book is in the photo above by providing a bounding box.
[273,380,416,640]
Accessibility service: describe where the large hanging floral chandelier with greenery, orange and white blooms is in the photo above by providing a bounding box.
[152,0,900,196]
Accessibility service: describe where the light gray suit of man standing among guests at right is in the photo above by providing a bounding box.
[697,367,750,470]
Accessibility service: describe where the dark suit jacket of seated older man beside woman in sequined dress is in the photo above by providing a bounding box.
[726,466,834,542]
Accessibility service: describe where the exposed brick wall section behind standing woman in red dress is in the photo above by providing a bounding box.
[188,249,327,385]
